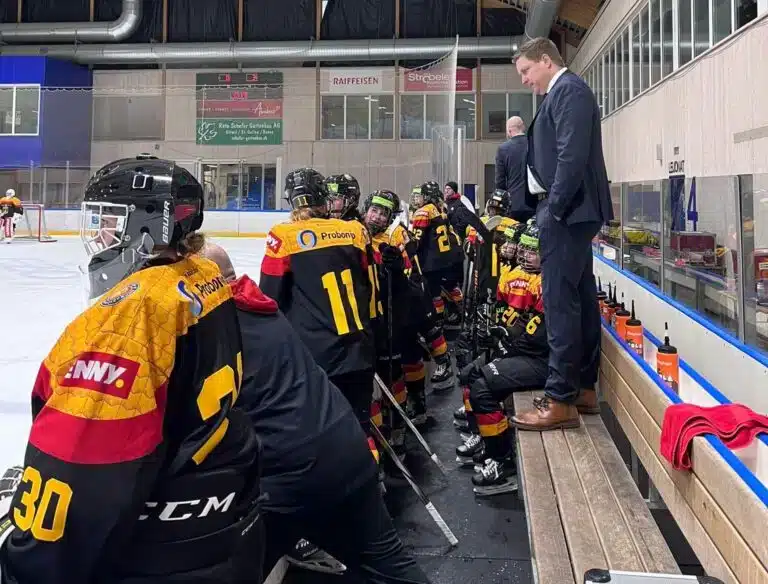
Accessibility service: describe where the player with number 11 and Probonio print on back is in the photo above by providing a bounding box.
[260,168,379,452]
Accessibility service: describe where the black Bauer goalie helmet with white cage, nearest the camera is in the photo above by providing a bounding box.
[80,155,204,299]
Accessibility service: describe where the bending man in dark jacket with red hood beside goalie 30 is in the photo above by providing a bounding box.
[203,243,429,584]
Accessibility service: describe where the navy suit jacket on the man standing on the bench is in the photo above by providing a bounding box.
[528,71,613,225]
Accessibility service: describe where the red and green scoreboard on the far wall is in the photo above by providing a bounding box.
[195,71,283,145]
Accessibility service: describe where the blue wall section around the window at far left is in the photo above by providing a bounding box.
[0,56,93,168]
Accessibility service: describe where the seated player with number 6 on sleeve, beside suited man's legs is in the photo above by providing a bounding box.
[456,220,549,495]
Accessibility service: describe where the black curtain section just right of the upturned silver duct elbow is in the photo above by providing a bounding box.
[168,0,237,43]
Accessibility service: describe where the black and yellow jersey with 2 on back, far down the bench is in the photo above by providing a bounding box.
[411,203,462,272]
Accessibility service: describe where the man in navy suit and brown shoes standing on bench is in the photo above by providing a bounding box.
[514,38,613,430]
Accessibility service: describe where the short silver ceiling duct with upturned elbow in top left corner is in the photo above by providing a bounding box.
[0,0,142,43]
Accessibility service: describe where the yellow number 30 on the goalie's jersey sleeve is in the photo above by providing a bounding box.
[13,466,72,543]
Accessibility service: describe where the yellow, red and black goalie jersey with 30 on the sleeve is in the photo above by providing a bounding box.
[0,257,258,584]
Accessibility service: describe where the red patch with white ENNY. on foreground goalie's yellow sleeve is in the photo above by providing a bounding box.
[59,351,139,399]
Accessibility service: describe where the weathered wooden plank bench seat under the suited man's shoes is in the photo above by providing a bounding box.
[514,392,680,584]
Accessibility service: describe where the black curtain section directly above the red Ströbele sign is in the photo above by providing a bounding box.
[400,0,477,39]
